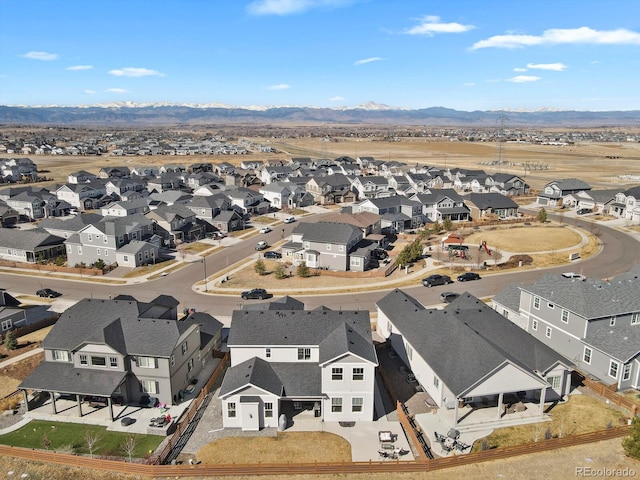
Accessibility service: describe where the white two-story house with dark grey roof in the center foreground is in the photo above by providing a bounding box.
[220,309,378,430]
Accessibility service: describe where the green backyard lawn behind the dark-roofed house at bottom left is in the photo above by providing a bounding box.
[0,420,164,458]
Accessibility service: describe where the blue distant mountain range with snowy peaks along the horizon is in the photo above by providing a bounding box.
[0,102,640,128]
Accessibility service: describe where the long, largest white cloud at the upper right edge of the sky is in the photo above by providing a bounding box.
[471,27,640,50]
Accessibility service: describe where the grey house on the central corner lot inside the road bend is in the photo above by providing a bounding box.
[282,222,377,272]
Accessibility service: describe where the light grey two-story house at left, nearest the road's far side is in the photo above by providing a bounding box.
[64,213,160,267]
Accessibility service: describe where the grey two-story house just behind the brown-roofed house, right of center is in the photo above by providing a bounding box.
[352,195,424,233]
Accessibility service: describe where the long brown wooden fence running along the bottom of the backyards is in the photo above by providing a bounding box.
[0,426,630,478]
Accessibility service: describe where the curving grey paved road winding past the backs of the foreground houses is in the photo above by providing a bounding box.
[0,215,640,318]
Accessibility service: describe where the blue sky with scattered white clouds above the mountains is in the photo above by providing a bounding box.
[0,0,640,111]
